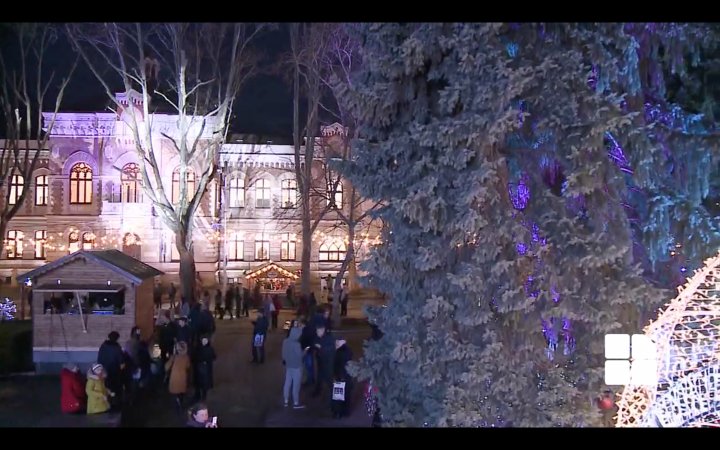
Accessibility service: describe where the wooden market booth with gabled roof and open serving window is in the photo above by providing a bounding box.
[17,250,163,373]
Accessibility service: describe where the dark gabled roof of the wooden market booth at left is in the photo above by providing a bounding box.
[17,249,163,284]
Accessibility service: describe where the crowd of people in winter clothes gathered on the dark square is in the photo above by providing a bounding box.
[61,283,362,428]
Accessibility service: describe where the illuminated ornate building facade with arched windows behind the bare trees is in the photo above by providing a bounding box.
[0,94,380,294]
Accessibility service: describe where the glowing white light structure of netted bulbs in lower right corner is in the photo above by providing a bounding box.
[617,254,720,427]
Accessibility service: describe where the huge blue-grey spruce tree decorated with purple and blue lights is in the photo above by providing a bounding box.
[340,23,719,426]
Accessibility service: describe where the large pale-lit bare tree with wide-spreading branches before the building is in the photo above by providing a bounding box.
[68,23,262,302]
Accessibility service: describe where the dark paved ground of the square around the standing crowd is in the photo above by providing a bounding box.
[0,302,382,428]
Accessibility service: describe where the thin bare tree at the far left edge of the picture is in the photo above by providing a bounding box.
[0,24,78,251]
